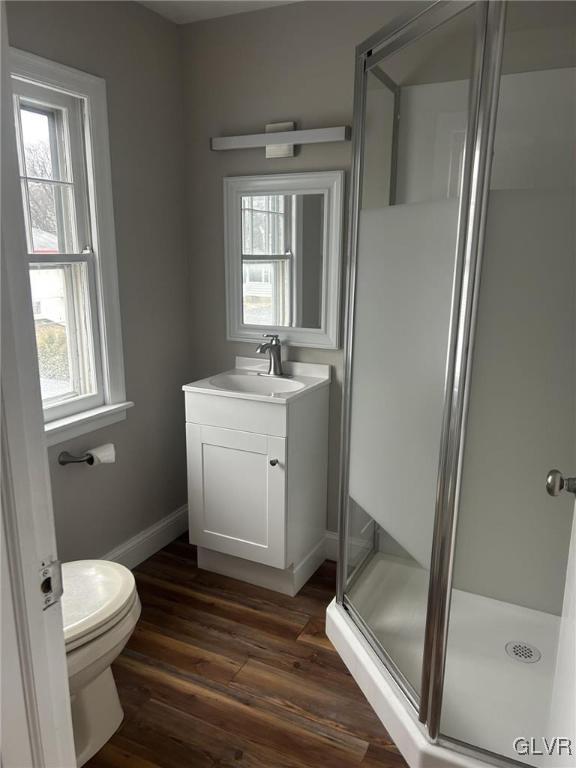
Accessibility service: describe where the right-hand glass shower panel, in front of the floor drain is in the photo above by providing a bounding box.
[441,2,576,768]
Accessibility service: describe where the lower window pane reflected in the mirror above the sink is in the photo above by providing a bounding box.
[242,259,290,326]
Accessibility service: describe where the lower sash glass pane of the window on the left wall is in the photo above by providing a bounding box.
[30,263,96,407]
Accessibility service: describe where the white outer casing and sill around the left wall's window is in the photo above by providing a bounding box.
[10,48,133,445]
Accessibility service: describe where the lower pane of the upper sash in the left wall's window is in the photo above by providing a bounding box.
[23,181,77,253]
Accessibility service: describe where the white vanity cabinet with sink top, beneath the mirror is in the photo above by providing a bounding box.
[184,358,329,594]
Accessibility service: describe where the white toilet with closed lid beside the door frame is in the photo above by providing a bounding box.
[62,560,141,766]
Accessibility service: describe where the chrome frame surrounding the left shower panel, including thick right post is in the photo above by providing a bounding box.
[336,0,505,752]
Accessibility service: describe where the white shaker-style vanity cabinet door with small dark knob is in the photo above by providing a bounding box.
[186,423,286,568]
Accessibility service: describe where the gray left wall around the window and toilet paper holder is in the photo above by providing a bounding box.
[8,2,192,560]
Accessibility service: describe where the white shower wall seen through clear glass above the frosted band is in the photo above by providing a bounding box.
[397,67,576,203]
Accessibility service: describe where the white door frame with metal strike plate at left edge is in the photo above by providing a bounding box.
[0,3,76,768]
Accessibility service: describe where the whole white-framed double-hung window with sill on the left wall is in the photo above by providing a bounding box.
[12,51,131,442]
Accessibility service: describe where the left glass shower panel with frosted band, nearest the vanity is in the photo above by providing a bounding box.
[344,3,481,703]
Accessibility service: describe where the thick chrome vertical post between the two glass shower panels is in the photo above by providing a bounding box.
[419,0,506,741]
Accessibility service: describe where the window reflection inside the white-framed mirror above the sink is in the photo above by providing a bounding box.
[242,195,293,326]
